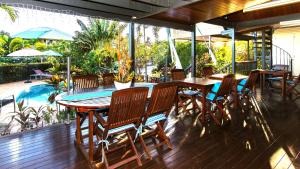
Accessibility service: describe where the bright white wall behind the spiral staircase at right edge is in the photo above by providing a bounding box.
[273,27,300,75]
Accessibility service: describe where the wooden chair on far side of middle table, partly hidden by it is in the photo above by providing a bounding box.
[171,69,200,115]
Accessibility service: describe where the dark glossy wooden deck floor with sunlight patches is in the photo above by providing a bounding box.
[0,91,300,169]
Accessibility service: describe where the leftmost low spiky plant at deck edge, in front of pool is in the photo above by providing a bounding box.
[12,100,31,131]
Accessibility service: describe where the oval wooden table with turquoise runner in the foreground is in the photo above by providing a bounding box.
[56,83,154,164]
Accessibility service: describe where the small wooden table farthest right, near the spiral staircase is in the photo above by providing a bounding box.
[259,69,291,100]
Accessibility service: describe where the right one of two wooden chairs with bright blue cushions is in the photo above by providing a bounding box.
[237,70,259,108]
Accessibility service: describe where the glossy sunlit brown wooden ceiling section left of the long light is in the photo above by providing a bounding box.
[151,0,269,24]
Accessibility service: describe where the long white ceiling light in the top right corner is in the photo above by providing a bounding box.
[243,0,300,13]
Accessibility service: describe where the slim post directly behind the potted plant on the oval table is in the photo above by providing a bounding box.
[128,22,135,83]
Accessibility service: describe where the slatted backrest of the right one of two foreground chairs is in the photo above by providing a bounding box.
[146,83,177,118]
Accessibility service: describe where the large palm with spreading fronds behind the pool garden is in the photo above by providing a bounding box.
[74,19,120,52]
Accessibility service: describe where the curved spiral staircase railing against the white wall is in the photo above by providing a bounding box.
[272,44,293,71]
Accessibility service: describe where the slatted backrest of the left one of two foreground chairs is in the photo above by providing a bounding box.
[107,87,149,129]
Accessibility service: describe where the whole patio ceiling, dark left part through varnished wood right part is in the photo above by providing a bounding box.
[2,0,269,31]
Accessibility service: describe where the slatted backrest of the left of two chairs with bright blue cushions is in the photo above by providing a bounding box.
[216,74,234,98]
